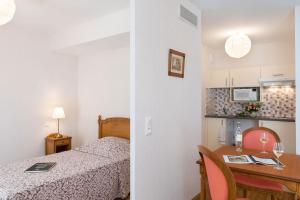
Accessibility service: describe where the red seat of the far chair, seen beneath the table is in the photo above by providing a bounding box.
[233,173,284,192]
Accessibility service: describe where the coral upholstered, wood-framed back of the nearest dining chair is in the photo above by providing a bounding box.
[198,145,236,200]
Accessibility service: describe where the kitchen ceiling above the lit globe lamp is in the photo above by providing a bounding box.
[191,0,300,47]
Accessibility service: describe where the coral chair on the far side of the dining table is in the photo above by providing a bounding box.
[234,127,284,199]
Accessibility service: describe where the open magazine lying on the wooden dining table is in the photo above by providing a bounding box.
[223,155,283,166]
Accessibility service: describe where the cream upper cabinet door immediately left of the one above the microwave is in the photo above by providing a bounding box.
[208,69,229,88]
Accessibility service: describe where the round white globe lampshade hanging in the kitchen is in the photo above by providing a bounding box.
[225,33,251,58]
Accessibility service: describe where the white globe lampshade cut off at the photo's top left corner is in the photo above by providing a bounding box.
[0,0,16,25]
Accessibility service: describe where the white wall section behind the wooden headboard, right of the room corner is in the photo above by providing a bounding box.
[78,46,129,144]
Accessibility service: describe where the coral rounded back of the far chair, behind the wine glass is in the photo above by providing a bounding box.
[243,127,280,152]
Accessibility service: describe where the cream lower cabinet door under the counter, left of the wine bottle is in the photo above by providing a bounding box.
[206,118,226,151]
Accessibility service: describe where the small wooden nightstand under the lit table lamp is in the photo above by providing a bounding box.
[45,135,72,155]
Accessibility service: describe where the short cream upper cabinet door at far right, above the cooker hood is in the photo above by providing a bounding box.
[261,66,295,79]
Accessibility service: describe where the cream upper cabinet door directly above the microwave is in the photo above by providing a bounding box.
[230,67,260,87]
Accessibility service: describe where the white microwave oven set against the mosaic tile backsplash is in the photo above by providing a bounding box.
[231,87,260,102]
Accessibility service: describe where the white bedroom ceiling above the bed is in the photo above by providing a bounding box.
[8,0,129,34]
